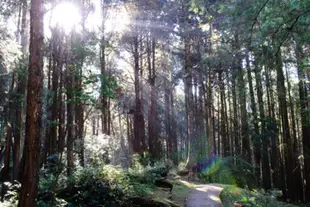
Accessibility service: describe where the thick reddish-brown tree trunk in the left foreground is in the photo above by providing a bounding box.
[18,0,44,204]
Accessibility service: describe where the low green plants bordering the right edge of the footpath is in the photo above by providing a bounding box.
[220,186,294,207]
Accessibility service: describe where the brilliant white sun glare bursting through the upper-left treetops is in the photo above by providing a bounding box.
[44,2,82,33]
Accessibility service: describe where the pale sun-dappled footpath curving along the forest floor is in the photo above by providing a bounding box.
[185,184,225,207]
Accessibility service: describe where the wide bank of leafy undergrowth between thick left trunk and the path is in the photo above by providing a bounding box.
[37,157,173,207]
